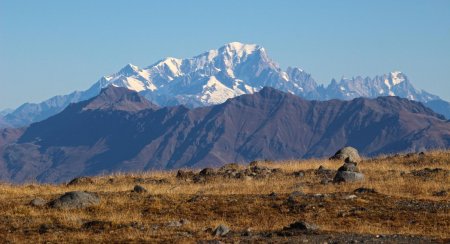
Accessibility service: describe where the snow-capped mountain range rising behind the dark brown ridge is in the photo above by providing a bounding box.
[0,42,450,128]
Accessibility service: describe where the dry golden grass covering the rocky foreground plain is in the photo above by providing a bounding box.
[0,151,450,243]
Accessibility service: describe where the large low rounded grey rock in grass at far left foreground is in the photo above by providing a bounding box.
[48,191,100,209]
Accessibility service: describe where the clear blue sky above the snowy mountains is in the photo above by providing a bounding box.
[0,0,450,109]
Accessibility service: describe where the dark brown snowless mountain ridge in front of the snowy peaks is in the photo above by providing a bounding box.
[0,85,450,182]
